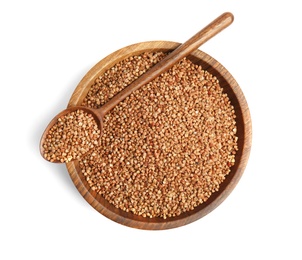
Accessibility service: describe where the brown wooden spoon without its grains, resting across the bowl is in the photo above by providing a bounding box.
[40,12,234,163]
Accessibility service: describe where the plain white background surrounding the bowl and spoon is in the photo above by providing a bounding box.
[0,0,302,260]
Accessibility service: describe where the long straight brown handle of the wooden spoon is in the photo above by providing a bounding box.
[100,13,234,115]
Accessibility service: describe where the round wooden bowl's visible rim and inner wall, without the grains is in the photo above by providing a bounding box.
[67,41,251,230]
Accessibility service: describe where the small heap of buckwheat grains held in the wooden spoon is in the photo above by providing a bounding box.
[43,110,100,162]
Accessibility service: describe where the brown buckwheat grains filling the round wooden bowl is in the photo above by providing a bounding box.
[79,52,238,218]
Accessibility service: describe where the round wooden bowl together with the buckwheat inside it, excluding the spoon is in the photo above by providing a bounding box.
[67,42,250,229]
